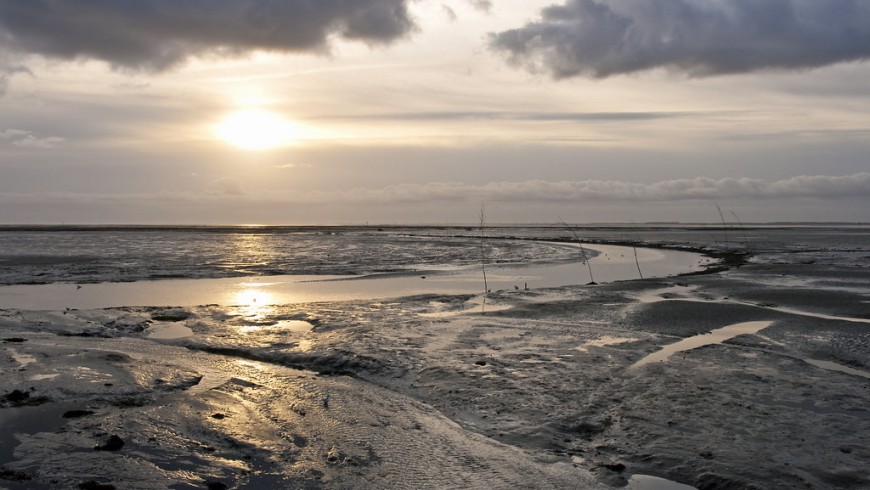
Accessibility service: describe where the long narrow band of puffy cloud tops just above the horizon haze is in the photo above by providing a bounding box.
[0,172,870,205]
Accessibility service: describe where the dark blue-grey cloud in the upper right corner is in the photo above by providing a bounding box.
[489,0,870,78]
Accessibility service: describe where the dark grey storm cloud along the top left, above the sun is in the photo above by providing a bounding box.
[0,0,414,72]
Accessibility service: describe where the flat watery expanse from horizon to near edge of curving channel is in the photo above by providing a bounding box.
[0,223,870,309]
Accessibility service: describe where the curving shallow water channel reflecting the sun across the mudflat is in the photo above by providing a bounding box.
[0,244,710,310]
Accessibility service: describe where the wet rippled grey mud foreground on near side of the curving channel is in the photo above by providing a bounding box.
[0,231,870,489]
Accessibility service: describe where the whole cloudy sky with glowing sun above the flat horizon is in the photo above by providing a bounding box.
[0,0,870,225]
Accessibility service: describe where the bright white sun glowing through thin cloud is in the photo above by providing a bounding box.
[215,109,301,151]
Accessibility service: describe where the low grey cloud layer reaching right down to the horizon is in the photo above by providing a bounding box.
[0,173,870,224]
